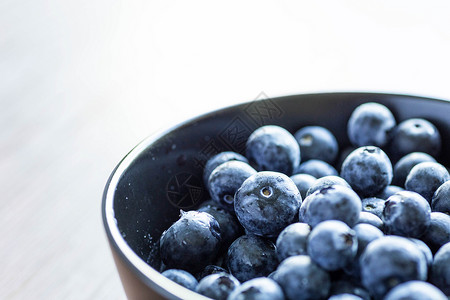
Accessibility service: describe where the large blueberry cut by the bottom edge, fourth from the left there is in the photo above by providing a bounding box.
[274,255,330,300]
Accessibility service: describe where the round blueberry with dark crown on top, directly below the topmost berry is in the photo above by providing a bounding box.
[341,146,392,197]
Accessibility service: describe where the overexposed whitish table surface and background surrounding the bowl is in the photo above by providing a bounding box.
[0,0,450,299]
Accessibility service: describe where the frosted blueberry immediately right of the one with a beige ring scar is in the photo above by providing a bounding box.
[300,185,361,227]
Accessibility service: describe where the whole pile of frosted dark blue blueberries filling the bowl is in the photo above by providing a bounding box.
[160,103,450,300]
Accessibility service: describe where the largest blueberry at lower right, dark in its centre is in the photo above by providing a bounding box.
[359,236,427,299]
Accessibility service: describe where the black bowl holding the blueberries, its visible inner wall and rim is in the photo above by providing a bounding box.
[102,93,450,299]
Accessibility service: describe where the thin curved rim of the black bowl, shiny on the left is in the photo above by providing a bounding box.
[101,91,450,300]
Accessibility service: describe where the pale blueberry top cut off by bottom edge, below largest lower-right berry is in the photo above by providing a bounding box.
[384,280,448,300]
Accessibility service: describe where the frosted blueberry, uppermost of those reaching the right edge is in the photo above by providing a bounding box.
[405,162,450,203]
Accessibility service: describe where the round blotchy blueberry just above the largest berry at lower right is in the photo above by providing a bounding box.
[383,191,431,238]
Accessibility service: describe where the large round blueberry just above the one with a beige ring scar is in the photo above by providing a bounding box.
[246,125,300,176]
